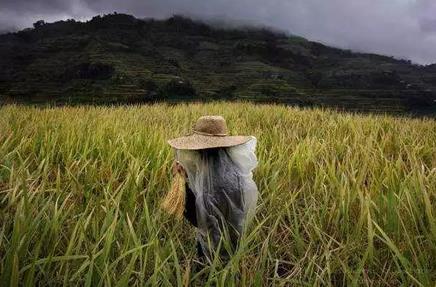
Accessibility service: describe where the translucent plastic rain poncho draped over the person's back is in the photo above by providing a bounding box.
[176,137,258,259]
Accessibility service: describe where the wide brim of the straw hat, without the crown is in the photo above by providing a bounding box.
[168,134,252,150]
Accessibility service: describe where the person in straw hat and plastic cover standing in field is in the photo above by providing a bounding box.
[164,116,258,262]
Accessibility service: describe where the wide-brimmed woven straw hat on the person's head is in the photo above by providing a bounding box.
[168,116,252,150]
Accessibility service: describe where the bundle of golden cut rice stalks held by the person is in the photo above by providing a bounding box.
[161,172,186,219]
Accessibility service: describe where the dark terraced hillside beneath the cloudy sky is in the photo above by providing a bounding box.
[0,14,436,111]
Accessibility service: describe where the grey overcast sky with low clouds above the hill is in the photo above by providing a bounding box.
[0,0,436,64]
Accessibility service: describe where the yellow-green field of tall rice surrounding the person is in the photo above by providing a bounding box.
[0,103,436,286]
